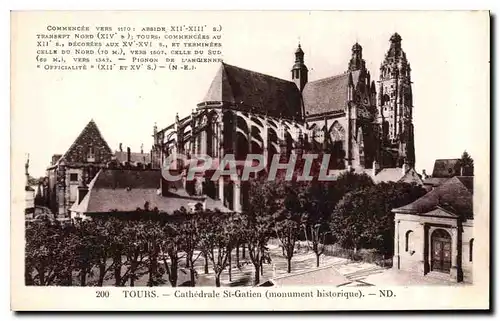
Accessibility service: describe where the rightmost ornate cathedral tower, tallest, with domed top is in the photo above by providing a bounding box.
[377,33,415,166]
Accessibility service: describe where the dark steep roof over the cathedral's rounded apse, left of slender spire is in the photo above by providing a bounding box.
[199,63,302,118]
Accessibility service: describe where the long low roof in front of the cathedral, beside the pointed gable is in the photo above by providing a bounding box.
[71,169,228,213]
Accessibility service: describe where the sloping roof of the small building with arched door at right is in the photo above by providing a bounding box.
[392,177,473,218]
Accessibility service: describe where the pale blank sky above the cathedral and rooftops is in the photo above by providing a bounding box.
[11,11,490,177]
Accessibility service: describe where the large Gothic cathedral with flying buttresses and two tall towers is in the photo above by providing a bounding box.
[151,33,415,211]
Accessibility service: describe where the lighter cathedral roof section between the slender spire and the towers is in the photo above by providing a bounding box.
[302,70,361,116]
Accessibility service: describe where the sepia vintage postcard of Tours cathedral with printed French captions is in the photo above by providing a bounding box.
[11,11,491,311]
